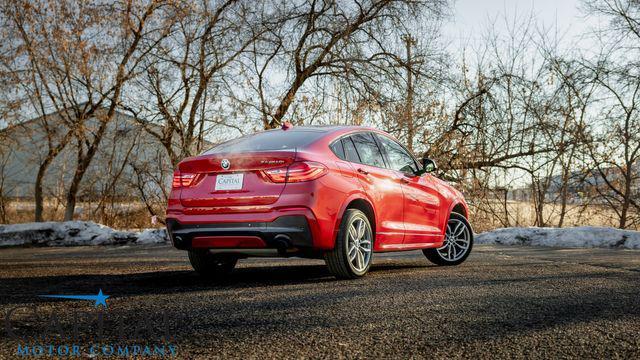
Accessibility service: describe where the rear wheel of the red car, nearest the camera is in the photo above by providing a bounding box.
[324,209,374,279]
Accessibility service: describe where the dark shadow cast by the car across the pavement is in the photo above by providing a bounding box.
[0,263,428,305]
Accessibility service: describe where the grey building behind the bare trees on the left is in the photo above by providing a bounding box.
[0,108,173,199]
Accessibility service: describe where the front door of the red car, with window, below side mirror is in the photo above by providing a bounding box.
[376,134,440,245]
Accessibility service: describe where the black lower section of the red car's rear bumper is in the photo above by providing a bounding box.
[167,215,313,253]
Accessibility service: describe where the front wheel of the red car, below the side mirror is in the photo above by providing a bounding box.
[422,212,473,266]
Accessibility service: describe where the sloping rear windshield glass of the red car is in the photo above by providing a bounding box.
[205,130,324,154]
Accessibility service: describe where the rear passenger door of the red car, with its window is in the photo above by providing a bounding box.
[342,132,404,249]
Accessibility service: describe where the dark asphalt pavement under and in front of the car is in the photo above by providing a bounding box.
[0,246,640,358]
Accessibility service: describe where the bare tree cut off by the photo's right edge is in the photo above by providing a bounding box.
[584,0,640,228]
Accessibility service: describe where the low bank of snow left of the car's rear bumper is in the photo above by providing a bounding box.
[0,221,169,247]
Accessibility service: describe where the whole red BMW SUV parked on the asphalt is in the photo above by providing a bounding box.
[167,126,473,278]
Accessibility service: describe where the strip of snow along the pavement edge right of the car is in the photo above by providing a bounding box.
[475,226,640,249]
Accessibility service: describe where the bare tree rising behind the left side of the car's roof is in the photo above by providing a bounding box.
[126,0,260,165]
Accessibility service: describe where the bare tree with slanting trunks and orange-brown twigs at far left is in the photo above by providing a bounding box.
[3,1,170,220]
